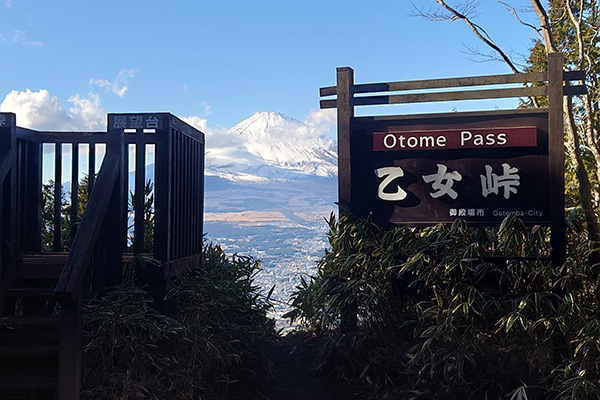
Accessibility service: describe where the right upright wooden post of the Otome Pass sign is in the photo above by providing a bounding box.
[548,53,567,266]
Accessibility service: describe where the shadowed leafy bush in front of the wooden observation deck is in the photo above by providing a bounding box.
[83,245,275,400]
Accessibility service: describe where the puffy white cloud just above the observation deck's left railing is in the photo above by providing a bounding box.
[0,89,106,131]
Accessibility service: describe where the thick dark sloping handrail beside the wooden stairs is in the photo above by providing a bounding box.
[54,151,121,302]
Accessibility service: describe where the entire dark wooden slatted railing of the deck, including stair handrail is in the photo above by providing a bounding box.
[0,113,204,399]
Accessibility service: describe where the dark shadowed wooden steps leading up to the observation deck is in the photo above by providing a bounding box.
[0,253,67,400]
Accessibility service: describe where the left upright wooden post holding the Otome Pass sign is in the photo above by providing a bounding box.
[337,67,354,206]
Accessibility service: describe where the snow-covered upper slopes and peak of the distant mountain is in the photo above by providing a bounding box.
[206,112,337,182]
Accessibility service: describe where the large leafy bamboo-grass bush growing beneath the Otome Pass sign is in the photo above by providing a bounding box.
[287,213,600,399]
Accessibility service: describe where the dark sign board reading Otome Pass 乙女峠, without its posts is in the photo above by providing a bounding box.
[351,112,550,226]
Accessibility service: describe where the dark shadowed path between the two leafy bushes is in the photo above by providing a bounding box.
[237,335,364,400]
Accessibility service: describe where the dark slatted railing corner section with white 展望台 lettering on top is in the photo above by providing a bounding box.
[109,114,204,278]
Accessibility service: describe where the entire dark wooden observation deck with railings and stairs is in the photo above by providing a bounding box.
[0,113,204,400]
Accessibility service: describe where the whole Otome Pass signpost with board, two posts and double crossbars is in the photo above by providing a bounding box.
[320,53,585,265]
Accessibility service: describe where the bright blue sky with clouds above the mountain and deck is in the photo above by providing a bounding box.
[0,0,536,134]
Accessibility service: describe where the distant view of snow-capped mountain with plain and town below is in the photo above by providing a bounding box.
[204,112,337,326]
